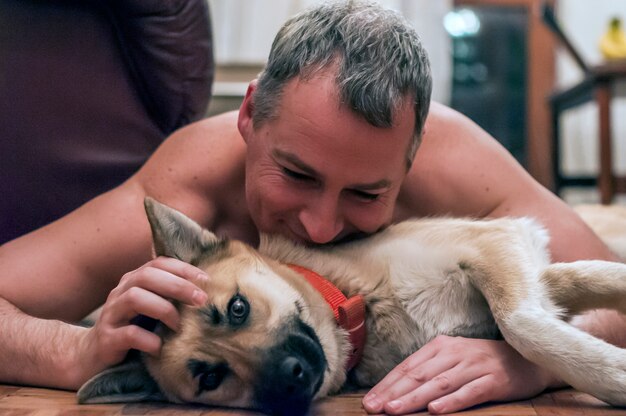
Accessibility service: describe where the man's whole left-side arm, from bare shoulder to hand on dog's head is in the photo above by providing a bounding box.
[0,113,239,389]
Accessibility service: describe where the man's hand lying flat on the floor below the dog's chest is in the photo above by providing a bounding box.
[363,335,554,414]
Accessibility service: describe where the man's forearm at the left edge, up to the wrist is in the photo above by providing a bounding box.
[0,298,87,389]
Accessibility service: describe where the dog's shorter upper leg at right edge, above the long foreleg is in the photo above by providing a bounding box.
[541,260,626,315]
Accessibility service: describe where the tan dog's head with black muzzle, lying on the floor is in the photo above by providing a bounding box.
[78,199,346,414]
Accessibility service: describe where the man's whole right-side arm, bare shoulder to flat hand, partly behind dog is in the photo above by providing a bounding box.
[364,104,626,414]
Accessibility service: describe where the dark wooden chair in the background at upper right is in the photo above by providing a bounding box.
[543,4,626,204]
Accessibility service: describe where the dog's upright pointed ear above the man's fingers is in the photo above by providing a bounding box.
[144,197,223,263]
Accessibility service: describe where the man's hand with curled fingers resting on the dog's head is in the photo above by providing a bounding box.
[81,257,208,380]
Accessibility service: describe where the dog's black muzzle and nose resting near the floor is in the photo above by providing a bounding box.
[255,319,326,415]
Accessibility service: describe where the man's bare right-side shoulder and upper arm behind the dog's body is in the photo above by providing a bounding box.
[403,103,618,261]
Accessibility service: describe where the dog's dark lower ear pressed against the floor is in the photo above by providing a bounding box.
[77,358,166,404]
